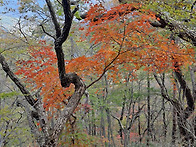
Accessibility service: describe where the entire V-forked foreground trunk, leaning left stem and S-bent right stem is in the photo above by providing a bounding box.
[0,0,86,147]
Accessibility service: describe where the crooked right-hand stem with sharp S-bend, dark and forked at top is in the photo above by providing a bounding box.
[46,0,86,145]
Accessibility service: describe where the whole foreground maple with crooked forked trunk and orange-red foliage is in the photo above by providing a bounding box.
[0,0,195,146]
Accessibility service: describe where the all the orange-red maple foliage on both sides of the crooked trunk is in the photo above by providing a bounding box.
[16,4,194,108]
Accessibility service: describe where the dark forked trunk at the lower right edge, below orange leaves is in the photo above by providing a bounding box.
[154,70,195,146]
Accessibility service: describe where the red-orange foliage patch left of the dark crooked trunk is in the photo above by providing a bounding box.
[16,41,73,109]
